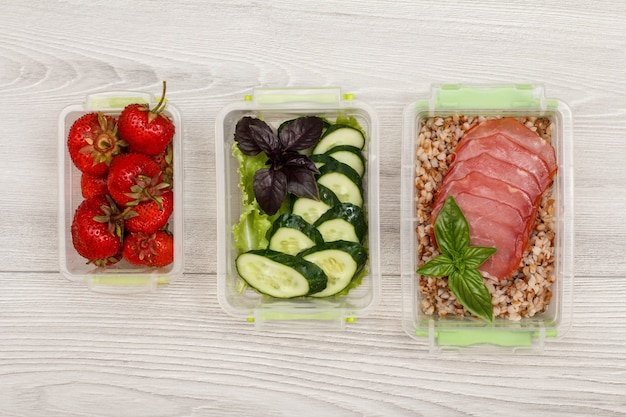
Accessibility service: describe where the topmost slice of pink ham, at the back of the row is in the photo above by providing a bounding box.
[464,117,557,174]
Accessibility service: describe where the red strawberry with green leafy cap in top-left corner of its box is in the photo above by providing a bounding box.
[67,112,126,177]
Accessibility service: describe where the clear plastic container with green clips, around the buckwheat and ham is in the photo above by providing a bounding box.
[401,85,574,353]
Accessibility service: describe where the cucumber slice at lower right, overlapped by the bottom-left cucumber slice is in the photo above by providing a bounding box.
[300,241,367,297]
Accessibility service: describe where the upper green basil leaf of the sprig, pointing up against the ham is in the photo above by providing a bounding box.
[435,196,470,259]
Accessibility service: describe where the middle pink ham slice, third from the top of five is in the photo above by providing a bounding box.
[440,153,543,204]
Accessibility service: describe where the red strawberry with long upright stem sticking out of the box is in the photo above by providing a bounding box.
[118,81,176,155]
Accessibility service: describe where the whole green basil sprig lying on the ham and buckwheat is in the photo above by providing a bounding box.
[417,196,497,323]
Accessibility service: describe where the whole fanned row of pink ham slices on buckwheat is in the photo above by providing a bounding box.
[431,118,557,280]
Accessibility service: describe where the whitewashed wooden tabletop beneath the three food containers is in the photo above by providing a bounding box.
[0,0,626,417]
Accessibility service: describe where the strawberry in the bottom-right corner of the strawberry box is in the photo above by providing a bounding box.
[122,230,174,267]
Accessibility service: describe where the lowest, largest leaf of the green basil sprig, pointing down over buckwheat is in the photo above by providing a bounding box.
[448,268,493,323]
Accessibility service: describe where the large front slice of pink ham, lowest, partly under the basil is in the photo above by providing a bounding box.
[435,193,529,280]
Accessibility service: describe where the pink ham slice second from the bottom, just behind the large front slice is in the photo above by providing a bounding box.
[433,171,537,224]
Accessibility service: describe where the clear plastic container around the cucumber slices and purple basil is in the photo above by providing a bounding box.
[215,88,380,330]
